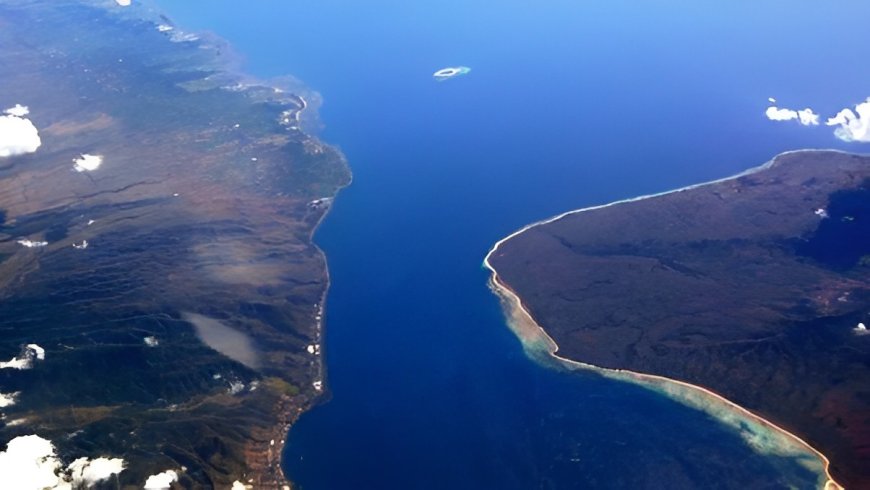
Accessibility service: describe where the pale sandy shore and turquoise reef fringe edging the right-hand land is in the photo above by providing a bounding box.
[483,149,849,490]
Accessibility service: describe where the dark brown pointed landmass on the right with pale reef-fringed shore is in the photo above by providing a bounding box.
[485,151,870,489]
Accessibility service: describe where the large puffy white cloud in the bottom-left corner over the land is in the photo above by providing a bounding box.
[0,435,124,490]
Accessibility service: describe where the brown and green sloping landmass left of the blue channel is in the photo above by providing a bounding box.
[0,0,350,488]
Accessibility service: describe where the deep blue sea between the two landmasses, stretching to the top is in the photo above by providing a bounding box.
[158,0,870,490]
